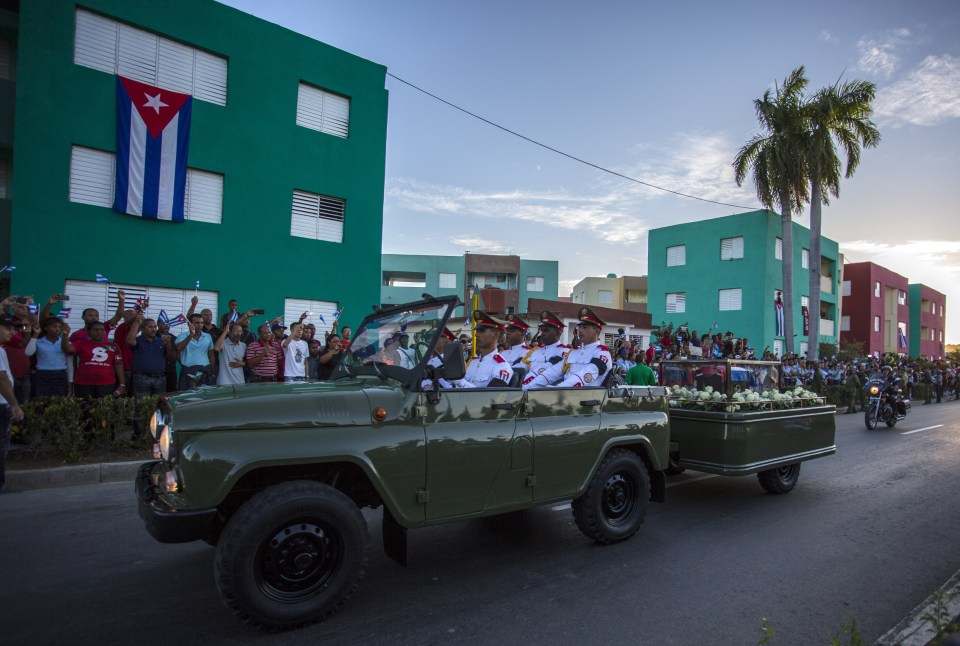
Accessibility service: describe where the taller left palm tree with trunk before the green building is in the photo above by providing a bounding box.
[733,66,809,354]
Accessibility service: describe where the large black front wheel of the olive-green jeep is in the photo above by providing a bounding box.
[214,481,368,631]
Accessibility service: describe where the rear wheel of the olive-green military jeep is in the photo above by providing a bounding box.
[571,449,650,545]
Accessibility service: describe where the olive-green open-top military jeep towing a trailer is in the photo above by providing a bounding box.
[136,297,670,630]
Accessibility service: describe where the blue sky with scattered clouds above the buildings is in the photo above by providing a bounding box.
[219,0,960,343]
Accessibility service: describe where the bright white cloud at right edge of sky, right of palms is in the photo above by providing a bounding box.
[874,54,960,127]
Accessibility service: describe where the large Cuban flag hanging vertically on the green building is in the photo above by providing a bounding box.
[113,76,193,222]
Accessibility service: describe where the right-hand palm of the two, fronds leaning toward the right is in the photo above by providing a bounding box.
[803,81,880,359]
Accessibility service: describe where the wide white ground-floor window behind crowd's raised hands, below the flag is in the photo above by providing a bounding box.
[63,280,218,342]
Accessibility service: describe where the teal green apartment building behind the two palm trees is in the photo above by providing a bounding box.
[647,211,842,357]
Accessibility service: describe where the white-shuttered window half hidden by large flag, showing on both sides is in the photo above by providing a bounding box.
[70,146,223,224]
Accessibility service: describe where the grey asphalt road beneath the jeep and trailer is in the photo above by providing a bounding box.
[0,402,960,646]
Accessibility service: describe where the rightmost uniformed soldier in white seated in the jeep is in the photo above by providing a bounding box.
[523,307,613,390]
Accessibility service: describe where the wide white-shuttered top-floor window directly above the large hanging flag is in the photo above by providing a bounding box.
[73,9,227,105]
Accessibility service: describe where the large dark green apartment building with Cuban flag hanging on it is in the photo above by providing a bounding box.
[0,0,387,328]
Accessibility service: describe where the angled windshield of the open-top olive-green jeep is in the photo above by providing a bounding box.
[332,297,458,382]
